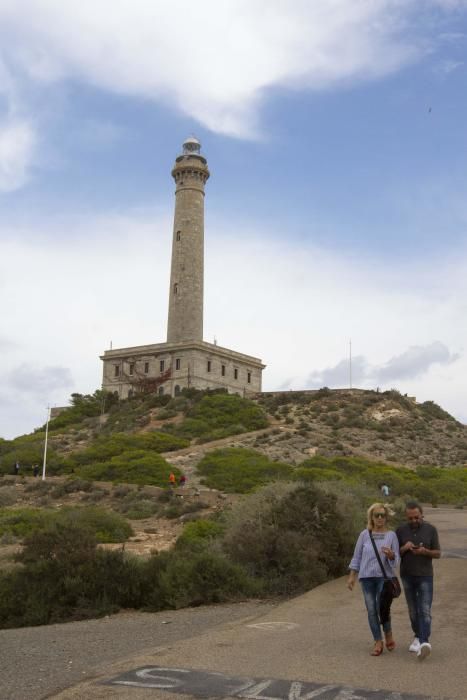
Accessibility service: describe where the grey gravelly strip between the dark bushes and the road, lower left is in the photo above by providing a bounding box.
[0,602,274,700]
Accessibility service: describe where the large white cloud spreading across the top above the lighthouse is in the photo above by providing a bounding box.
[0,0,436,137]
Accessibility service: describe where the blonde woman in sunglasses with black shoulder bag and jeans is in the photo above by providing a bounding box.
[347,503,400,656]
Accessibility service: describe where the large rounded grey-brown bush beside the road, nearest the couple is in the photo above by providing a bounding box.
[223,484,356,594]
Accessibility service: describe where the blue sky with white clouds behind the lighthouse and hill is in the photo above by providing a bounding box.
[0,0,467,438]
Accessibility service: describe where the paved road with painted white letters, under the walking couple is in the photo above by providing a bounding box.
[0,508,467,700]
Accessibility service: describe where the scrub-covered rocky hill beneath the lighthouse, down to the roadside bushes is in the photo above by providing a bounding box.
[0,389,467,627]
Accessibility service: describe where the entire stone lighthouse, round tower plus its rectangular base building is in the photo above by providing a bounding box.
[101,138,265,398]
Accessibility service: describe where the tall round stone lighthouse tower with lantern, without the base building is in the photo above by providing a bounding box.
[167,137,209,343]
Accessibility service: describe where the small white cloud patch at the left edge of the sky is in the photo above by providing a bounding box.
[0,120,36,192]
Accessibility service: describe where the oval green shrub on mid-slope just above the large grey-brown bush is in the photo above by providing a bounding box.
[196,447,292,493]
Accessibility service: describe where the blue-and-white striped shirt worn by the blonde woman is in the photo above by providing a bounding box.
[349,530,400,579]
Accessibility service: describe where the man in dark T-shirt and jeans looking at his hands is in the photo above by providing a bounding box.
[396,501,441,661]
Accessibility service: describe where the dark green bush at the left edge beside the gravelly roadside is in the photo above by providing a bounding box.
[0,522,142,628]
